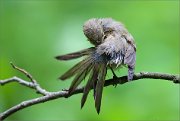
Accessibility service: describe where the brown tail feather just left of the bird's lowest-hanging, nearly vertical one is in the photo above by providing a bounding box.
[81,64,99,108]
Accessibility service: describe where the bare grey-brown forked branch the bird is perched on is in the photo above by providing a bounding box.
[0,64,180,120]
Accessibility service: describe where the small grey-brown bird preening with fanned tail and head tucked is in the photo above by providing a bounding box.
[56,18,136,114]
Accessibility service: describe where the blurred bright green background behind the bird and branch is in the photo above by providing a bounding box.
[0,0,180,120]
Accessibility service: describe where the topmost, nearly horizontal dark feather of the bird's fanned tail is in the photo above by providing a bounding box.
[55,47,95,60]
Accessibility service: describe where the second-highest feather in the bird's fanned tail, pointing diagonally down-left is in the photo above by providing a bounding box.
[59,57,92,80]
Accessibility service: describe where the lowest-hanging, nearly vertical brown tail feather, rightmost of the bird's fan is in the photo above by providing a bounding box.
[95,63,107,114]
